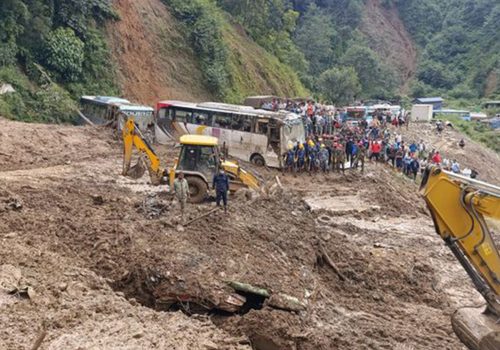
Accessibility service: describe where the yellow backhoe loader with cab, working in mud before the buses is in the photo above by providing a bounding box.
[122,118,261,203]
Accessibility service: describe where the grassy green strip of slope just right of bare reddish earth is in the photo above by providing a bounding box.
[163,0,307,102]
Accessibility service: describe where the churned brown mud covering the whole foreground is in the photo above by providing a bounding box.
[0,119,498,350]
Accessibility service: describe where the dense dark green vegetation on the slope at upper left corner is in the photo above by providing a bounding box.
[0,0,116,122]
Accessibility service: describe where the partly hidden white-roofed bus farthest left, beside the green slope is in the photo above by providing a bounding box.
[80,96,154,131]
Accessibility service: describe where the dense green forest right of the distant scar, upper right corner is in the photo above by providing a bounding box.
[394,0,500,99]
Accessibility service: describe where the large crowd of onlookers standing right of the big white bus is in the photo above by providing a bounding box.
[283,98,477,181]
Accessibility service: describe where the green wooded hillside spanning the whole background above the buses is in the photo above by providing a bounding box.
[0,0,500,122]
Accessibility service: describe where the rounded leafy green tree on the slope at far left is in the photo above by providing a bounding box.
[46,28,85,82]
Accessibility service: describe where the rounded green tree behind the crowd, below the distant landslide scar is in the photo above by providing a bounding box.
[318,67,361,105]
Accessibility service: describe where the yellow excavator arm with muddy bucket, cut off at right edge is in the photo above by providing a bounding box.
[420,166,500,350]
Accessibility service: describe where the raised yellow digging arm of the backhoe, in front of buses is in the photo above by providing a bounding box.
[122,118,164,185]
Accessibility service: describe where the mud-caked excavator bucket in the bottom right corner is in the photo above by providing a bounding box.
[451,307,500,350]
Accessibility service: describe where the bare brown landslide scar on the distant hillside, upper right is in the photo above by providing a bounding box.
[361,0,417,92]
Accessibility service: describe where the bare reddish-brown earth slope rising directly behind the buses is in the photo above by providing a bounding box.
[108,0,213,105]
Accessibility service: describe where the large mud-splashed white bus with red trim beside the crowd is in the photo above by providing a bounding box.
[155,101,305,168]
